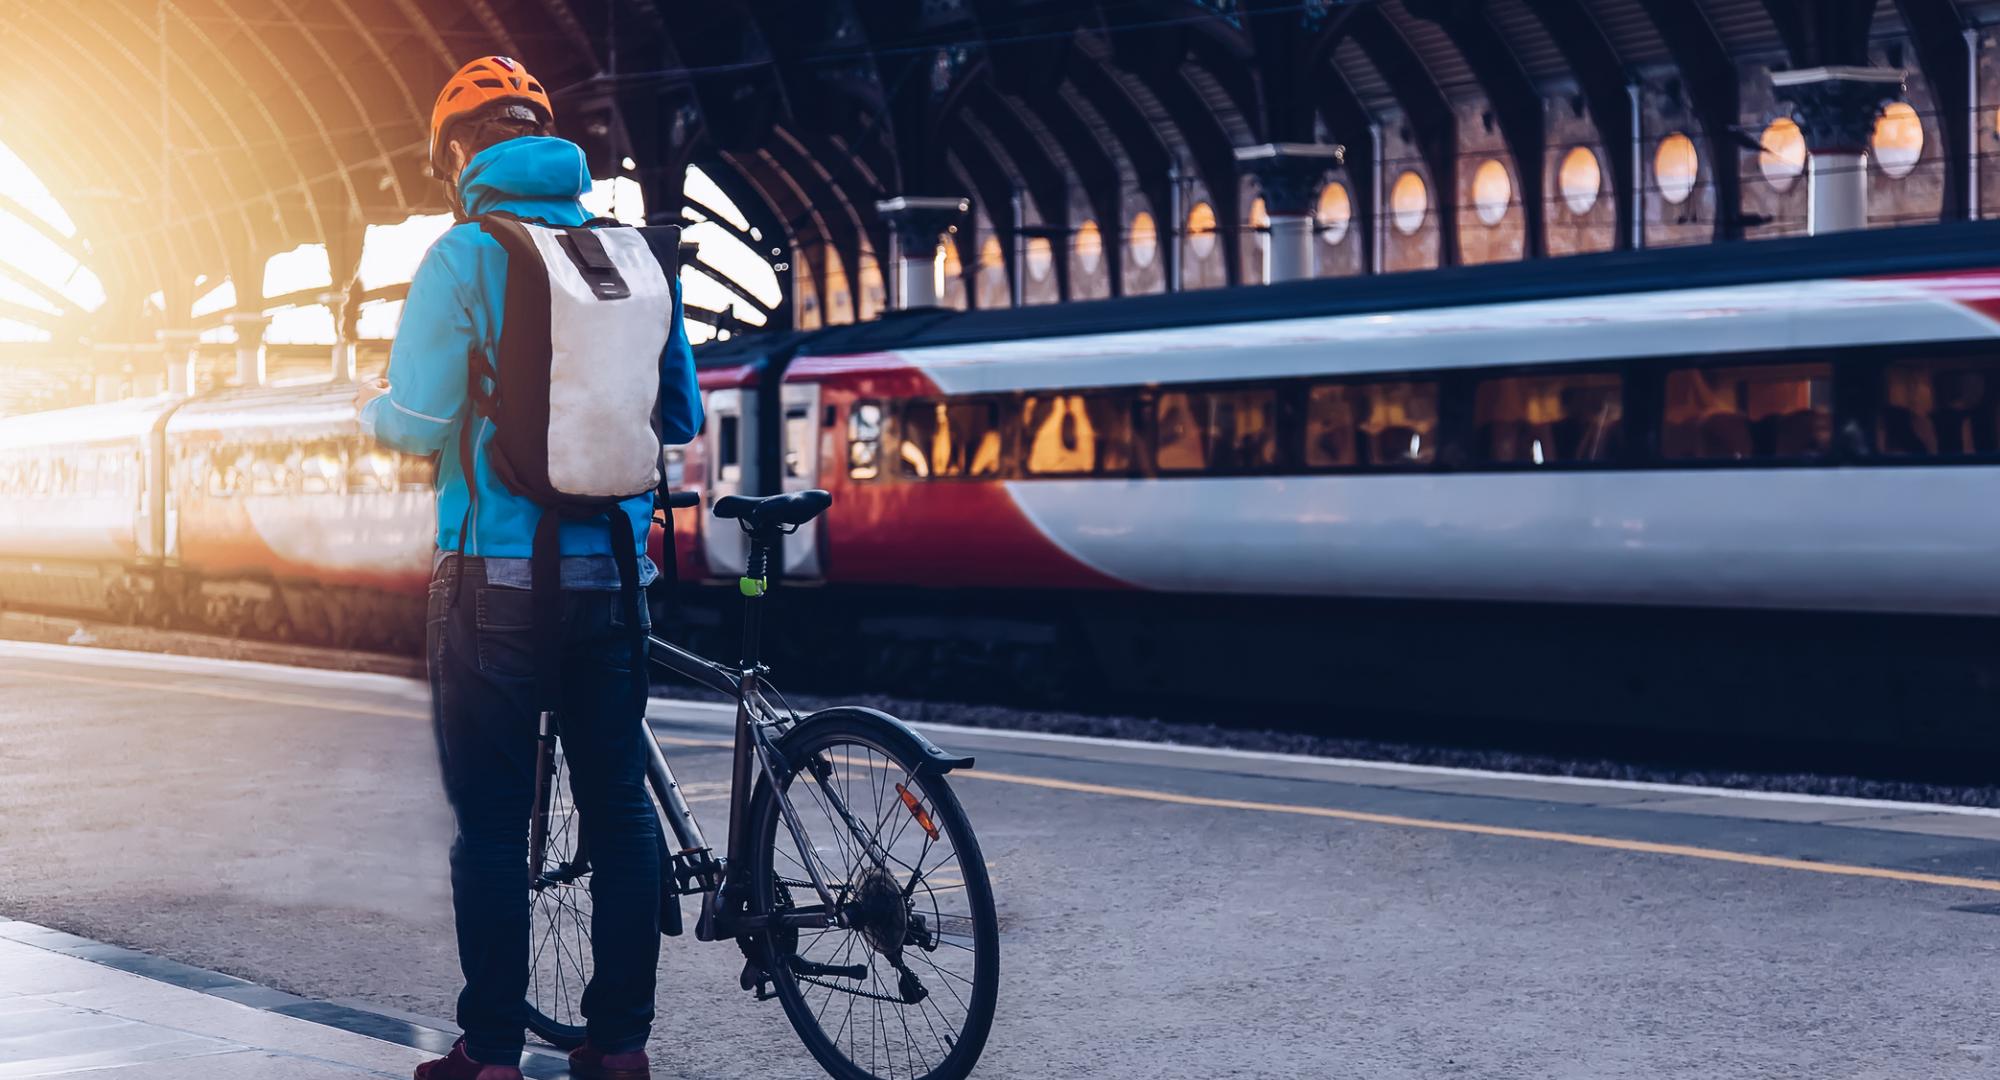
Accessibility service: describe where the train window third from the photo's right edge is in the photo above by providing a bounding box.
[1472,374,1624,464]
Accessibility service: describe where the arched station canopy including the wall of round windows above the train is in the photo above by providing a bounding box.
[0,0,2000,354]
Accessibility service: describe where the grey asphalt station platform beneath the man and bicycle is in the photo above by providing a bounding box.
[0,644,2000,1080]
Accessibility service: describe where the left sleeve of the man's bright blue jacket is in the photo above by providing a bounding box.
[360,234,478,454]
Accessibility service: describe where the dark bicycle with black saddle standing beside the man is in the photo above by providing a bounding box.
[526,490,1000,1080]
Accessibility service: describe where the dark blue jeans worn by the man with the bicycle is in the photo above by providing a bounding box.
[426,556,662,1064]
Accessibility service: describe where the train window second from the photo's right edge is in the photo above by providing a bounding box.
[1660,364,1834,460]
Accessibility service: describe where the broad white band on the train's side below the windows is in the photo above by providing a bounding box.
[1008,466,2000,614]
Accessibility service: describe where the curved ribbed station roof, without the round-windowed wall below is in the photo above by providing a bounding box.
[0,0,2000,336]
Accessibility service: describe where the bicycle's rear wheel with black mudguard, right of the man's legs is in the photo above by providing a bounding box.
[750,710,1000,1080]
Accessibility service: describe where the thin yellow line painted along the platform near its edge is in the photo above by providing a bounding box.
[15,670,2000,892]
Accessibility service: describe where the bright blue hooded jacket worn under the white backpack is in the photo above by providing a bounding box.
[360,136,702,558]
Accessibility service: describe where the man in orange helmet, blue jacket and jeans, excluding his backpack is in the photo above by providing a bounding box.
[358,56,702,1080]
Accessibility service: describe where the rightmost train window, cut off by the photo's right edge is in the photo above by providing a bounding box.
[1876,358,2000,456]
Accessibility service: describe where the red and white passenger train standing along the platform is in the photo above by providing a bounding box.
[11,224,2000,748]
